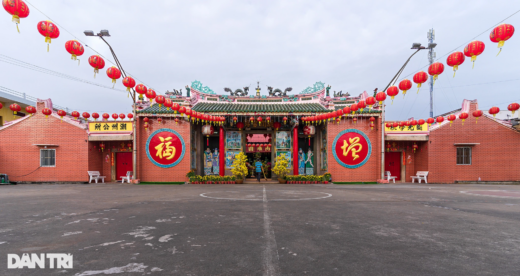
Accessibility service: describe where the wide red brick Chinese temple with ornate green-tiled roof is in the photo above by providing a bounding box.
[0,81,520,183]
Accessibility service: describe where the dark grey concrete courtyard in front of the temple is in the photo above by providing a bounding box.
[0,184,520,275]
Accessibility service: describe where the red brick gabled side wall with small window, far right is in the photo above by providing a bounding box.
[428,103,520,183]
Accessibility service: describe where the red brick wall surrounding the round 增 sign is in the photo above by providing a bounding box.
[327,117,381,182]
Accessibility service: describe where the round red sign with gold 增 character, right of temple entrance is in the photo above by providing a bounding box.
[332,129,372,169]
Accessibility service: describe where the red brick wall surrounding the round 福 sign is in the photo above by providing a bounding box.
[136,117,190,182]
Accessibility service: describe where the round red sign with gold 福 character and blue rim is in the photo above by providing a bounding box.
[146,128,185,168]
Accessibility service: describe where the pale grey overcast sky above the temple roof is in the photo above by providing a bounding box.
[0,0,520,120]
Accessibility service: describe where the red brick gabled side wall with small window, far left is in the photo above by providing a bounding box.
[0,103,89,182]
